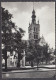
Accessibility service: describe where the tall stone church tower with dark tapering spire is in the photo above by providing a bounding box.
[28,3,40,42]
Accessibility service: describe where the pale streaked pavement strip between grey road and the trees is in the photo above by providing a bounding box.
[2,65,56,74]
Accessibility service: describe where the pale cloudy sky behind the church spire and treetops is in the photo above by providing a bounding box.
[1,2,55,49]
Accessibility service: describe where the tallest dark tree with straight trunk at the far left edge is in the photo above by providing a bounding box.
[2,8,14,70]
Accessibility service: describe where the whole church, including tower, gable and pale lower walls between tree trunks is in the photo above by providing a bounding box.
[2,5,46,67]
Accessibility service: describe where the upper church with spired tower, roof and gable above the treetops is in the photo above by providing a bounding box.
[23,9,46,46]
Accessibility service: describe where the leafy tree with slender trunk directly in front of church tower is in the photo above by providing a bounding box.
[28,41,42,69]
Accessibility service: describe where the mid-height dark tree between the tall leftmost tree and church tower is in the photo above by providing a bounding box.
[13,28,25,67]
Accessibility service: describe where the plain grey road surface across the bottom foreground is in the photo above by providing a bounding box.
[2,69,55,79]
